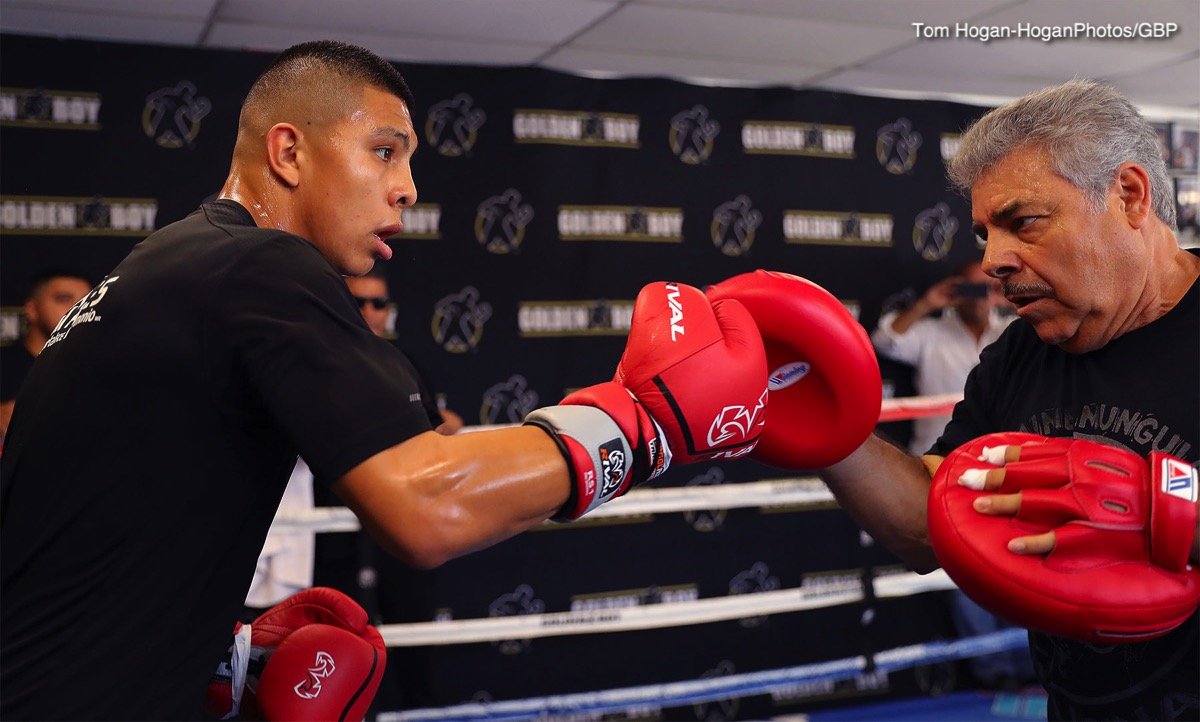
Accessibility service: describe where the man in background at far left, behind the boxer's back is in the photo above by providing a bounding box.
[0,269,91,437]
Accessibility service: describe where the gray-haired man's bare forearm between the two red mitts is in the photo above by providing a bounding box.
[821,435,938,573]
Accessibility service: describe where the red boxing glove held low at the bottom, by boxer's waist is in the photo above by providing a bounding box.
[206,586,388,722]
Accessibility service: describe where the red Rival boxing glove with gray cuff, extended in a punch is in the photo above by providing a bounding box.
[526,282,767,519]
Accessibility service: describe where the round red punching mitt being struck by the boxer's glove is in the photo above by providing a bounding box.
[706,270,883,470]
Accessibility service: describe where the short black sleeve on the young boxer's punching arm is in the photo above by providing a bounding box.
[212,234,432,480]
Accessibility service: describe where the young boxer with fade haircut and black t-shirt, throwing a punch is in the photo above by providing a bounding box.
[0,41,767,720]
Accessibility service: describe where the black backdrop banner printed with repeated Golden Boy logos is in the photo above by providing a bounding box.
[0,35,983,716]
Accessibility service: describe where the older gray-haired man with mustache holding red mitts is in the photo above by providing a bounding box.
[822,75,1200,720]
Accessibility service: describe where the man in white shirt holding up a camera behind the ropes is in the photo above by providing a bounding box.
[871,259,1033,688]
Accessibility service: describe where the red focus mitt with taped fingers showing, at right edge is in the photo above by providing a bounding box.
[929,432,1200,644]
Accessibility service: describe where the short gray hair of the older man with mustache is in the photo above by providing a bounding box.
[949,79,1176,230]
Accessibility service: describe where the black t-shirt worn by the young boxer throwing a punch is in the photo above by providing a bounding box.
[0,200,431,720]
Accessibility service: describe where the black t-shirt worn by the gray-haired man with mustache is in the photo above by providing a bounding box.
[931,255,1200,720]
